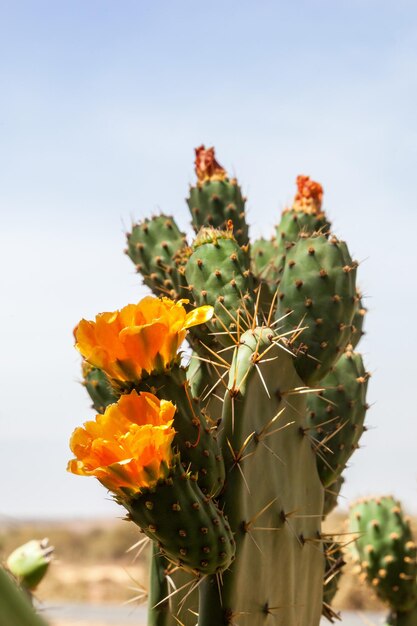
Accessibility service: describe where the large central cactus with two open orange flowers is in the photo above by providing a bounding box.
[68,146,366,626]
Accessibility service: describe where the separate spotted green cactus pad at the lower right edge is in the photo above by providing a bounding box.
[349,496,417,608]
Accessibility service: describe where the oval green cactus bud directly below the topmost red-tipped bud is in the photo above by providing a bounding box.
[185,228,254,346]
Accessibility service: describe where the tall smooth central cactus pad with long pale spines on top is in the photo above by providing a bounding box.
[198,328,324,626]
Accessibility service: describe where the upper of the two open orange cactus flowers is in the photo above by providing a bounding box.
[74,296,213,382]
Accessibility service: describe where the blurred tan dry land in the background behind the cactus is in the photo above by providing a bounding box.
[0,512,417,611]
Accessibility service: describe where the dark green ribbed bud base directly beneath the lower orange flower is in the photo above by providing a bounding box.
[122,462,235,575]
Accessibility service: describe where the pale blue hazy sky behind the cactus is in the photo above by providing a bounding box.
[0,0,417,518]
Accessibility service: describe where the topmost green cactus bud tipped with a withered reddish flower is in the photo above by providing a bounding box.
[187,146,249,246]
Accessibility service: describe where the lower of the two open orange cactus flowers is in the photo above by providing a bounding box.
[67,391,176,494]
